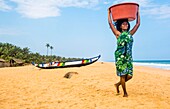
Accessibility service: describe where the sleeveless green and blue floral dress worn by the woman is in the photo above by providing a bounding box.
[115,32,133,76]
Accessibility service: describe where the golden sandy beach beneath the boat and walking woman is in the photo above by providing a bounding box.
[0,62,170,109]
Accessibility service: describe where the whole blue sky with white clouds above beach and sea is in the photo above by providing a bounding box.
[0,0,170,61]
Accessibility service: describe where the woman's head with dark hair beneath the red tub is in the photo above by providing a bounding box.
[116,19,130,32]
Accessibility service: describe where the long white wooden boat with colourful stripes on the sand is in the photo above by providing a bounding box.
[32,55,101,69]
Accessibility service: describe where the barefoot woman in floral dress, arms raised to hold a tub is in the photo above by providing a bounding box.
[108,10,140,97]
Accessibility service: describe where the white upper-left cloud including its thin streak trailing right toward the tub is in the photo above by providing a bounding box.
[8,0,99,19]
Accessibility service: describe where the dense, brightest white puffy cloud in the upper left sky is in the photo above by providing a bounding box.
[12,0,60,19]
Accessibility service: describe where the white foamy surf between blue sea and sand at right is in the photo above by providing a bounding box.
[133,62,170,70]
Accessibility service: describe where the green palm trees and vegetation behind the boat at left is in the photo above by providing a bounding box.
[0,42,79,63]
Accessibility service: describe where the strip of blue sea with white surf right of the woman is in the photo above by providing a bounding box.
[133,60,170,70]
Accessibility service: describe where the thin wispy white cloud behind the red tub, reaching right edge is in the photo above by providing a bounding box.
[113,0,170,19]
